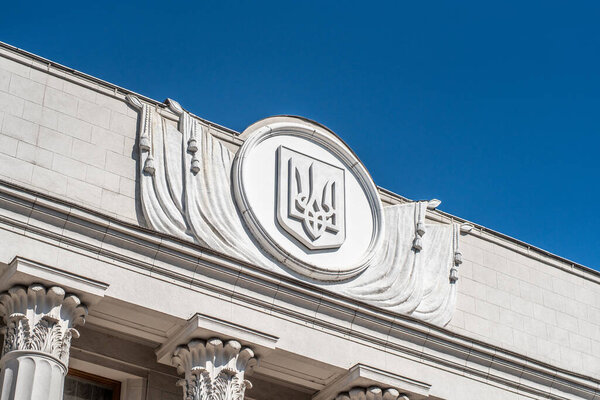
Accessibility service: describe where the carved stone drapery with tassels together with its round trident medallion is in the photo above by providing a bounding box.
[128,96,465,326]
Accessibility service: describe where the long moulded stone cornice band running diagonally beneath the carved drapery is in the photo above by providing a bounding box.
[0,183,600,399]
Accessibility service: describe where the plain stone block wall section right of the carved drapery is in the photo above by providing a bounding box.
[449,234,600,377]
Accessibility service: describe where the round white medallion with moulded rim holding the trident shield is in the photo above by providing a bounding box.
[233,117,383,280]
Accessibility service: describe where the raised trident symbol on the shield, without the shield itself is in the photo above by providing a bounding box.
[292,163,339,240]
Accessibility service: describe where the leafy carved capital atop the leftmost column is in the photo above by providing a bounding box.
[0,284,87,366]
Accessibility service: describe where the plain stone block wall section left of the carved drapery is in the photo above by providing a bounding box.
[0,49,137,223]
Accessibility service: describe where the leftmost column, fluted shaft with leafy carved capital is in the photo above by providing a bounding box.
[0,284,87,400]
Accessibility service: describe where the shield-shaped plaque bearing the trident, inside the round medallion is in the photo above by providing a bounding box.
[277,146,345,249]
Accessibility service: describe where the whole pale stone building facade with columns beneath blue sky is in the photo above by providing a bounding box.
[0,44,600,400]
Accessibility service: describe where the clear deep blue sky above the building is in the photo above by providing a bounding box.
[0,1,600,269]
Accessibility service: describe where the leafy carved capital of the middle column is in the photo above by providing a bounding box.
[172,338,256,400]
